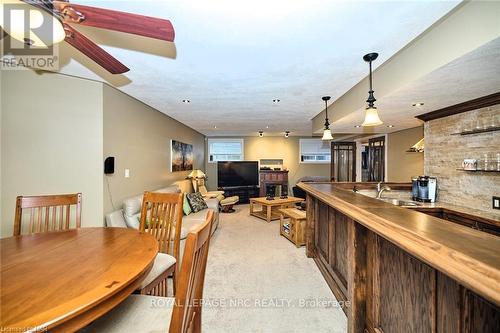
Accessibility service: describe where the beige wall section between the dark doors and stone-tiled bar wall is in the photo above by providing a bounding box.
[386,126,424,182]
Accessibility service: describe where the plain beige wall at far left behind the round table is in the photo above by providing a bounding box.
[0,70,103,237]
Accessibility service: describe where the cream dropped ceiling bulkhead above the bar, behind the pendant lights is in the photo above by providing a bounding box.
[332,38,500,134]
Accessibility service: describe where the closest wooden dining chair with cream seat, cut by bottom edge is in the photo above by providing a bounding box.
[80,210,214,333]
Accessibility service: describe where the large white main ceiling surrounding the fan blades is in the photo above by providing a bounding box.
[50,0,459,135]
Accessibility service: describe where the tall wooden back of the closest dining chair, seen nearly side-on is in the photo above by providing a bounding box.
[169,210,214,333]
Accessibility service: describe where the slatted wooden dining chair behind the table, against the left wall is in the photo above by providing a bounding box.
[14,193,82,236]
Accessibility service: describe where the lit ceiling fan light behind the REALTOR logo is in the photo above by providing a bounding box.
[0,1,66,48]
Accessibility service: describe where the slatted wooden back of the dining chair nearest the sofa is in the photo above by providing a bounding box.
[139,192,182,255]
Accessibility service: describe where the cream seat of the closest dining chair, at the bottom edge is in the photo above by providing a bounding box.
[79,295,175,333]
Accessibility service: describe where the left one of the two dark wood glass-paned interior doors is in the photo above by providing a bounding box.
[330,142,356,182]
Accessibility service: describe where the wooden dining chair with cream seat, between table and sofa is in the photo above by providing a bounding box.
[138,192,183,296]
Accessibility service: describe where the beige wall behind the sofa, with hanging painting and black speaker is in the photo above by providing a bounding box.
[103,85,205,214]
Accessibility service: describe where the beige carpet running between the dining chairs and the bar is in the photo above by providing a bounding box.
[203,205,347,333]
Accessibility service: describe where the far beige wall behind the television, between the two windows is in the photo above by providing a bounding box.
[206,136,330,190]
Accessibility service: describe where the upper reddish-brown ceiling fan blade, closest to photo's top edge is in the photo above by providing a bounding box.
[53,1,175,42]
